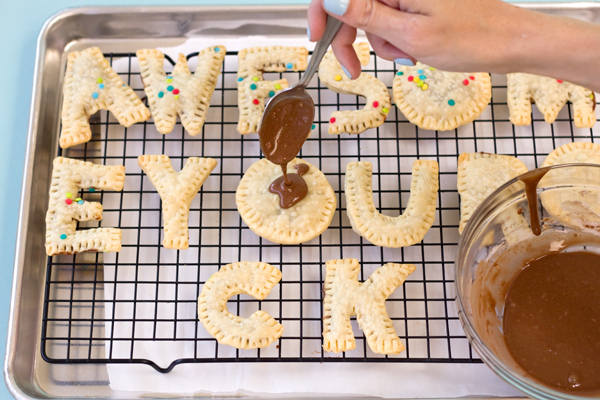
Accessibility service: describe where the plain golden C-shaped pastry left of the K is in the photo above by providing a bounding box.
[198,261,283,349]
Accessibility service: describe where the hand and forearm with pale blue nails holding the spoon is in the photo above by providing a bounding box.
[308,0,600,88]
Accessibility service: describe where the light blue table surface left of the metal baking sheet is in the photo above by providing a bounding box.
[0,0,580,399]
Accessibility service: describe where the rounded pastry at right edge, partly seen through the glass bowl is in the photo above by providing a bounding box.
[539,142,600,217]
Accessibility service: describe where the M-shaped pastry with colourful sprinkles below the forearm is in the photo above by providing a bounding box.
[506,73,596,128]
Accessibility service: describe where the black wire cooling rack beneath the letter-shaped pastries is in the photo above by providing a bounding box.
[41,51,594,372]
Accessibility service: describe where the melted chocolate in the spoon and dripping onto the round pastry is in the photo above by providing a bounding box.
[258,88,315,208]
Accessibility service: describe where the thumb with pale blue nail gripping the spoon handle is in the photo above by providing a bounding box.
[323,0,409,42]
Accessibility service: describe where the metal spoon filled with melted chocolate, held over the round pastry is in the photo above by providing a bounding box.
[259,16,342,166]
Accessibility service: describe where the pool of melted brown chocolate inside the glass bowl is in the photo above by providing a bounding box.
[503,251,600,392]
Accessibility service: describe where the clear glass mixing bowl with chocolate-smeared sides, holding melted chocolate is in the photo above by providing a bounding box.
[455,164,600,399]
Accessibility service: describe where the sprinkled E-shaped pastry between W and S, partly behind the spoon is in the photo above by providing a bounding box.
[237,46,308,135]
